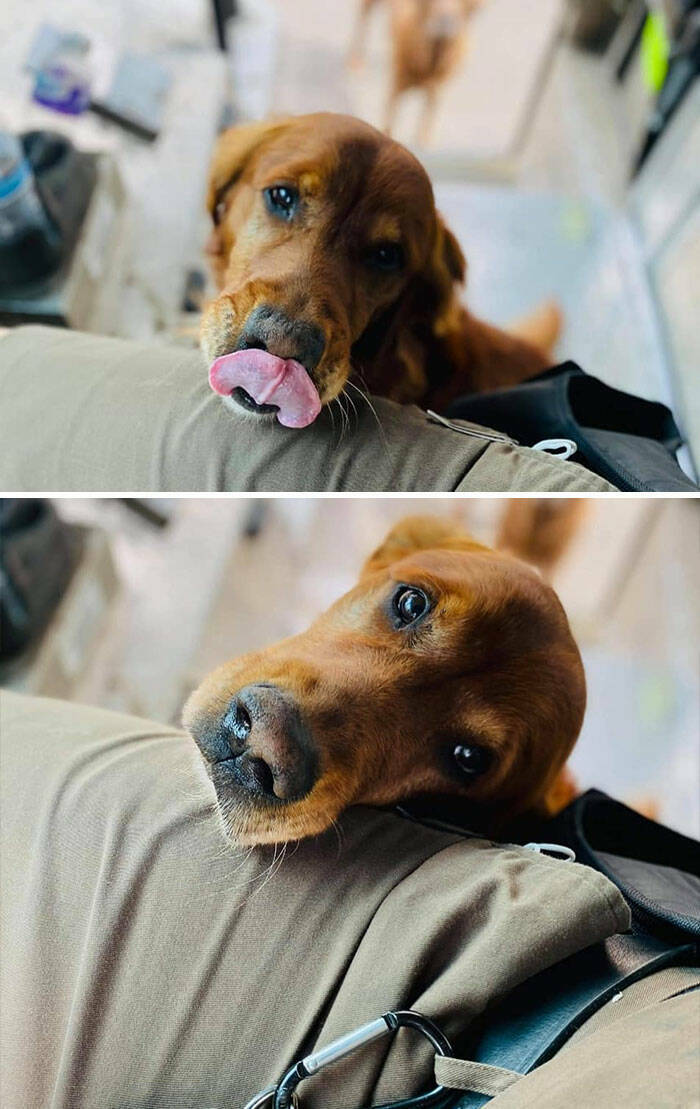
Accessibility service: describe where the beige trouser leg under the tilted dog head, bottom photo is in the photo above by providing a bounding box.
[0,693,629,1109]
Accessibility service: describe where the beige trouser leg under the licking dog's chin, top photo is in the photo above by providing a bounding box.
[0,326,612,494]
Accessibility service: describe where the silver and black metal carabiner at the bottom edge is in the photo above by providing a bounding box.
[268,1009,453,1109]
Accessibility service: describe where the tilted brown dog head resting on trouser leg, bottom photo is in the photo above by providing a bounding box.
[184,517,586,844]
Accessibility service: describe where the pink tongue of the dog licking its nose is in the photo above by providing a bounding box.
[209,349,321,427]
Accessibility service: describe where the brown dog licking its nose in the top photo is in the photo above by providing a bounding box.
[201,113,558,427]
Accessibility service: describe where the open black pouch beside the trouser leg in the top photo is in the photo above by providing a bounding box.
[447,362,698,492]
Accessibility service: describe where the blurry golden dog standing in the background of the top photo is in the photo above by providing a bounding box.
[351,0,484,146]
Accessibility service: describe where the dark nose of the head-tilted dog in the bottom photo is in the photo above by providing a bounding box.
[221,684,316,801]
